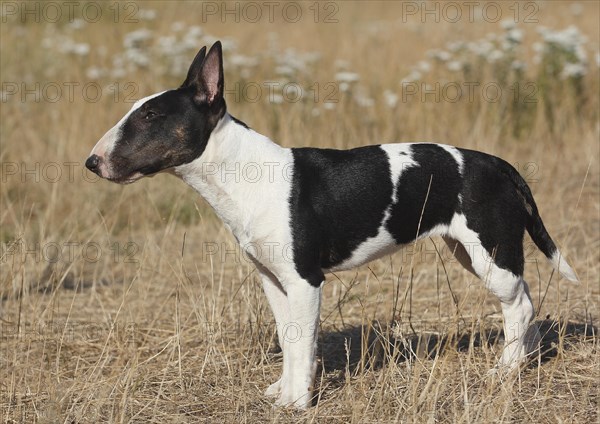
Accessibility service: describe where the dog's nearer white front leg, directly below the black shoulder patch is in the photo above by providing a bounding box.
[277,279,321,409]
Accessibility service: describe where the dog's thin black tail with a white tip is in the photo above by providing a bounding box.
[508,165,579,282]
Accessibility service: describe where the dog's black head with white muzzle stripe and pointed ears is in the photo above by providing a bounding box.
[85,41,226,184]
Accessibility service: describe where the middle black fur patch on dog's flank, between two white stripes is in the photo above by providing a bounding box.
[386,144,462,244]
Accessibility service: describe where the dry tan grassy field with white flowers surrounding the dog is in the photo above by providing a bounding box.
[0,1,600,423]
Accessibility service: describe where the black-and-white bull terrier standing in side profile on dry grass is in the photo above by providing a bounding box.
[85,42,577,408]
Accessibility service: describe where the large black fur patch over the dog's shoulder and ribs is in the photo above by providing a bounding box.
[290,146,392,286]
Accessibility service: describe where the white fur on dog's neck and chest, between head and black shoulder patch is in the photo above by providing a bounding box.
[174,115,299,274]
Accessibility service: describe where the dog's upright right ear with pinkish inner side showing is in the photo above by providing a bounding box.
[194,41,224,104]
